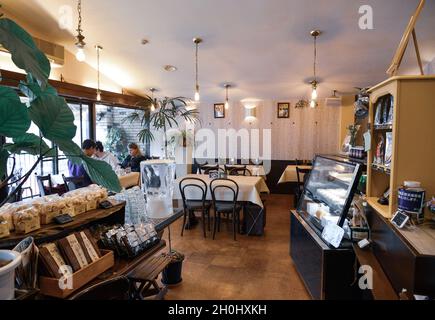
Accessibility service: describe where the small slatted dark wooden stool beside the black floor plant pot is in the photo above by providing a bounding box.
[127,255,171,300]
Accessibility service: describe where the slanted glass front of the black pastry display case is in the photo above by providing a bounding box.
[297,156,361,231]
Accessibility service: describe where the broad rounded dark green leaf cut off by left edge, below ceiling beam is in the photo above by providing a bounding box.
[0,87,30,137]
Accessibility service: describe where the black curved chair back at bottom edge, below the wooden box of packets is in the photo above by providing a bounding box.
[70,277,130,300]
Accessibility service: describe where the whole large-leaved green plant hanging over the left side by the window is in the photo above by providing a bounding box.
[0,15,121,206]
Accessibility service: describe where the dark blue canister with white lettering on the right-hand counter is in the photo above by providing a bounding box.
[398,182,426,215]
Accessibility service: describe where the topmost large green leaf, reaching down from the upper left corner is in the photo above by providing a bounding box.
[0,18,51,87]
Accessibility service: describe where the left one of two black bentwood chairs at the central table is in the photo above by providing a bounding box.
[178,178,211,238]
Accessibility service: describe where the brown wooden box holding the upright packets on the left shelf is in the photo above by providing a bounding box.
[39,250,115,299]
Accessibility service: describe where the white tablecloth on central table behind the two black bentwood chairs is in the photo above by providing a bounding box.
[174,174,270,207]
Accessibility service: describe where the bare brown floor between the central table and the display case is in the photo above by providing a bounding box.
[159,195,309,300]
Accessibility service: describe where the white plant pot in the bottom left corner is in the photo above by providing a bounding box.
[0,250,21,300]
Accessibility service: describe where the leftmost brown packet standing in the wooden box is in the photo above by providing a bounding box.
[39,243,72,279]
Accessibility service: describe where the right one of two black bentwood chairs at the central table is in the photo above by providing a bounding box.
[210,178,242,240]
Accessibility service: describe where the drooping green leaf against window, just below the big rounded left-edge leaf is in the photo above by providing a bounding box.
[5,133,55,157]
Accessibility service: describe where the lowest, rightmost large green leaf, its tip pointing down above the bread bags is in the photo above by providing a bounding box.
[82,156,122,192]
